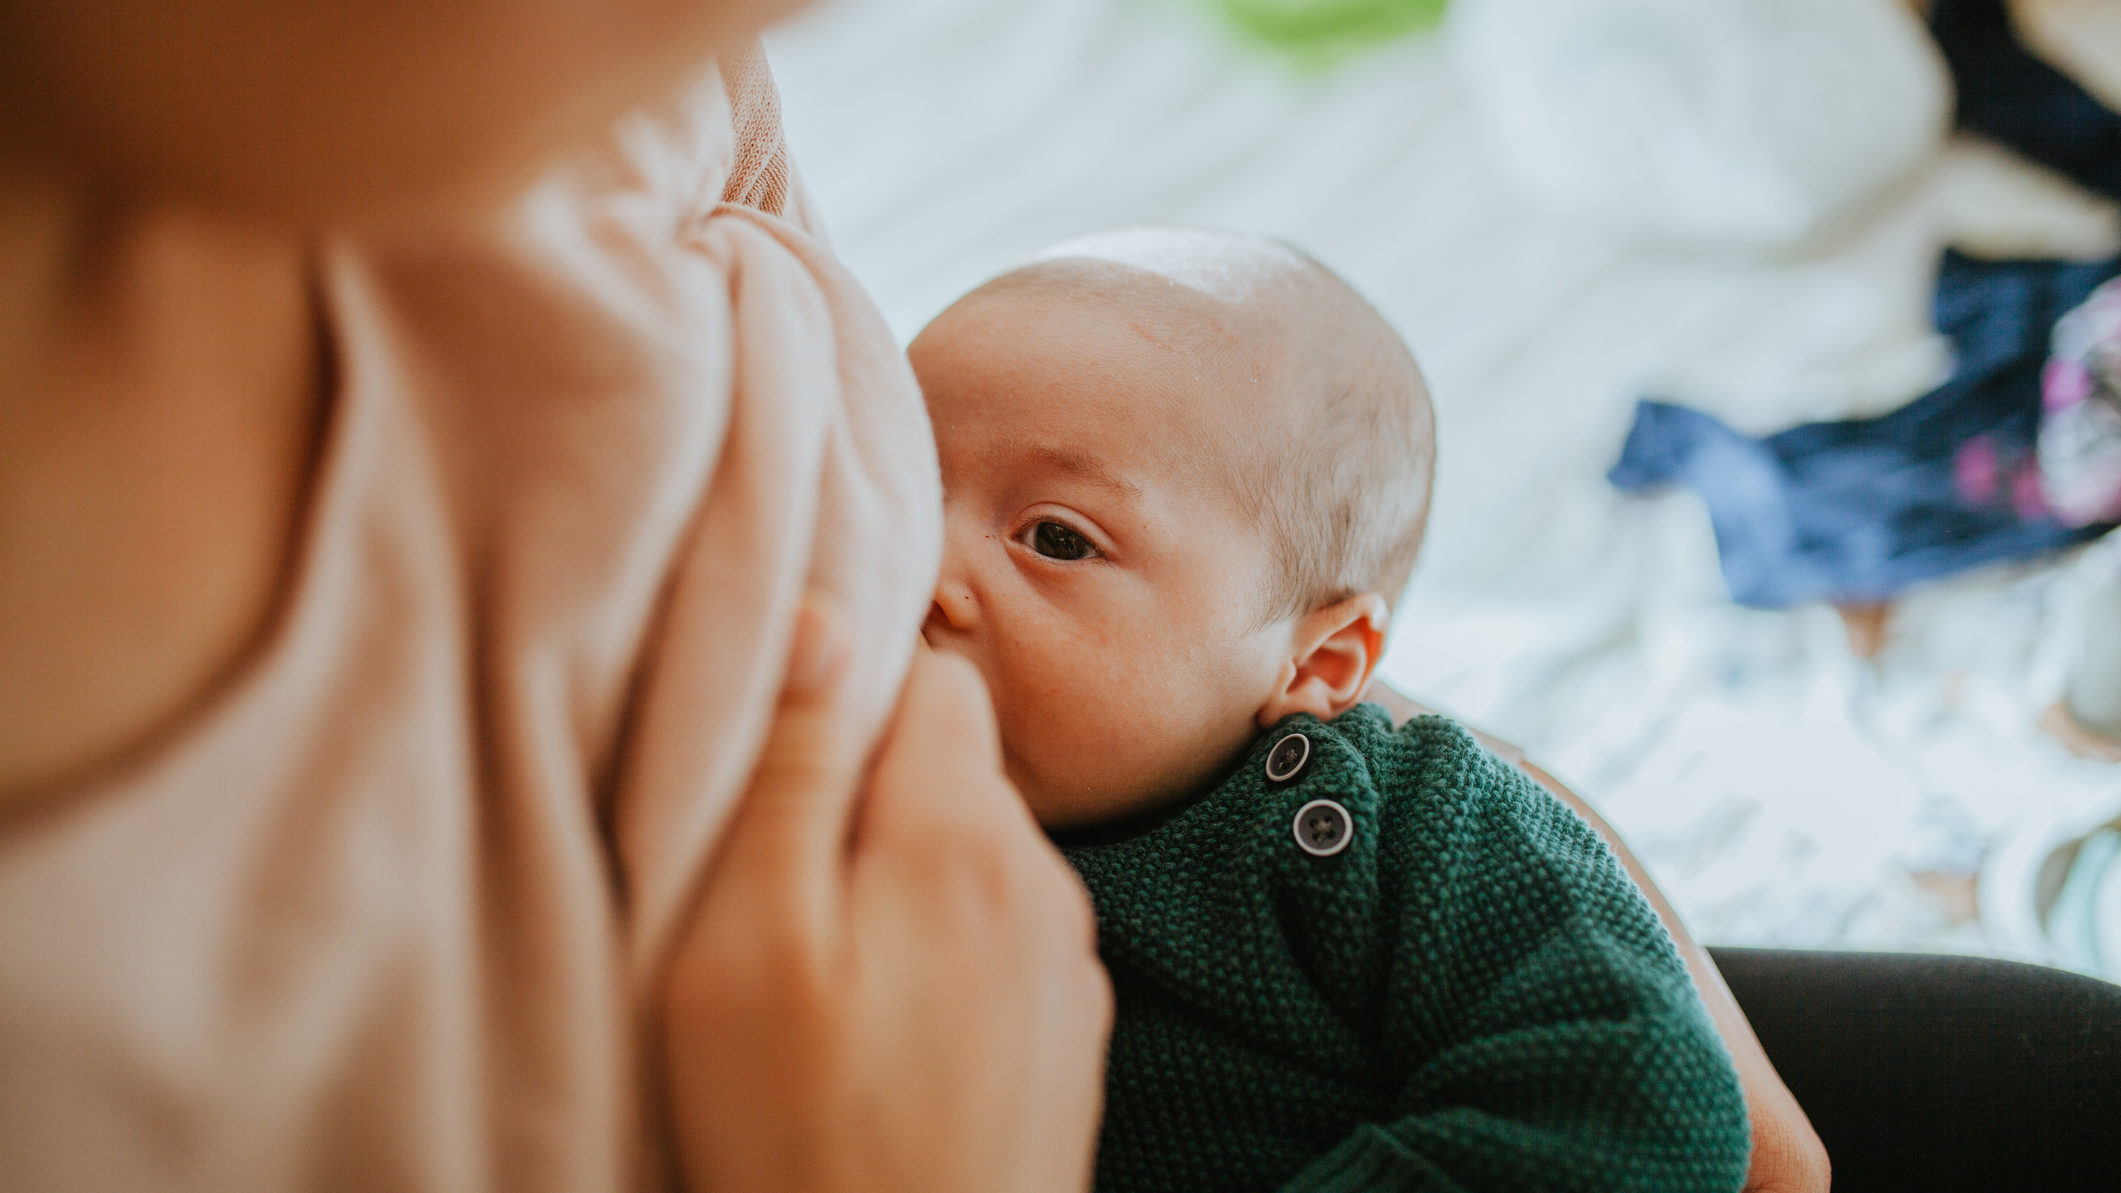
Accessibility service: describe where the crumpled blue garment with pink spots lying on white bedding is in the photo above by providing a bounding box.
[1610,250,2121,609]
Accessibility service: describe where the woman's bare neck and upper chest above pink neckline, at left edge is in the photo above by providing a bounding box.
[0,170,325,793]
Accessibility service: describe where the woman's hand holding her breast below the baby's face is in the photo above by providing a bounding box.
[664,609,1111,1193]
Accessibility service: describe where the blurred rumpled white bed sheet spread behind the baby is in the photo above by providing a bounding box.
[768,0,2121,955]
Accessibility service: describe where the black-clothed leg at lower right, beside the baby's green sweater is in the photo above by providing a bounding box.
[1710,949,2121,1193]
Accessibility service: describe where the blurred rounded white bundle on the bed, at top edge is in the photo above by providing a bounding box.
[1451,0,1951,246]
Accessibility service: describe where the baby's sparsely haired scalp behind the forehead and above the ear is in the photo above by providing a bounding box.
[959,227,1436,618]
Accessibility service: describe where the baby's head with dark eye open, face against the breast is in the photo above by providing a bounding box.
[910,229,1434,828]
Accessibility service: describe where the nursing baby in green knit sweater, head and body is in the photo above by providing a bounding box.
[910,229,1748,1193]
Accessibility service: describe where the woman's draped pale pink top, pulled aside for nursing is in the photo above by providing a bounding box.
[0,51,940,1193]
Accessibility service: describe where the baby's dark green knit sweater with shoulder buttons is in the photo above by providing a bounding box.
[1063,705,1748,1193]
